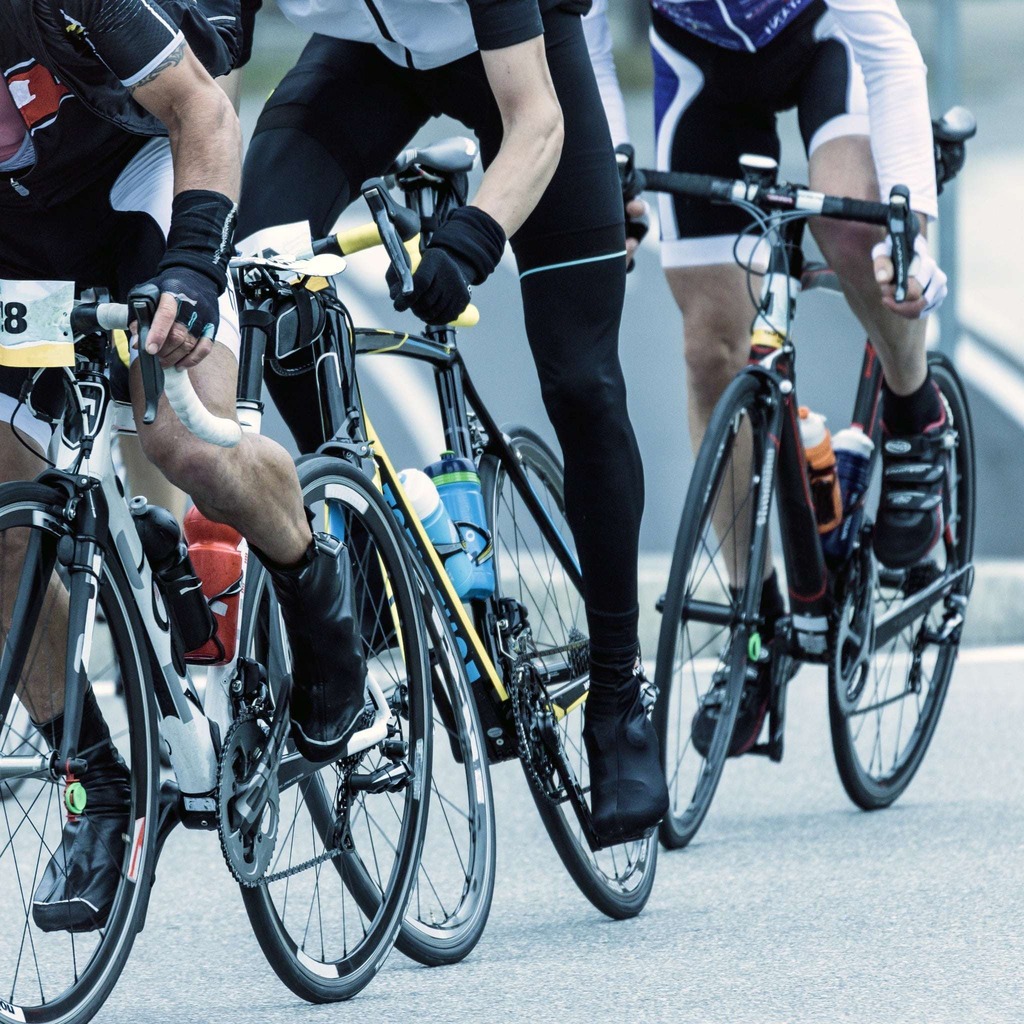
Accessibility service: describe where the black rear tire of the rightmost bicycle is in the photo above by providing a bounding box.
[828,352,976,811]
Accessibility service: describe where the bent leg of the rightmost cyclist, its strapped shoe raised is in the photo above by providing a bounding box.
[800,18,947,567]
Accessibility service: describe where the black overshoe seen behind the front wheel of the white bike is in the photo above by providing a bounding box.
[32,689,131,932]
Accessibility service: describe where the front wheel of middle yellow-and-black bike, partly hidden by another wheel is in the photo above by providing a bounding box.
[387,552,497,967]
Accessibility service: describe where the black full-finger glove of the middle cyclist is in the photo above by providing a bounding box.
[387,206,505,324]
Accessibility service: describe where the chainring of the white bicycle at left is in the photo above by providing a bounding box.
[217,713,281,888]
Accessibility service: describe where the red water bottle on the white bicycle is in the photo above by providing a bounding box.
[184,507,249,665]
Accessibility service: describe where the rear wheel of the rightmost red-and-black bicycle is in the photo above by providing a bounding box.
[828,353,975,810]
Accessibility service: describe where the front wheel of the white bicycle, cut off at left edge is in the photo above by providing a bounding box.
[0,482,159,1024]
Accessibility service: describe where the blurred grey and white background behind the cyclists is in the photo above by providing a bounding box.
[235,0,1024,652]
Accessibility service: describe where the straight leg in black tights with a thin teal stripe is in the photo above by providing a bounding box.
[436,10,668,840]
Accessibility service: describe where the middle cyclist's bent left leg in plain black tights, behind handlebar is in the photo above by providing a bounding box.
[237,36,433,453]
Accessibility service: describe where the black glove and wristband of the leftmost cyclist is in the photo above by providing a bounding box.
[153,189,238,338]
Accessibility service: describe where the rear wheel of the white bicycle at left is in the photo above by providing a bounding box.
[242,457,433,1002]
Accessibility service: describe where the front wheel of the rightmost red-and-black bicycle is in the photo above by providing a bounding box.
[654,374,767,849]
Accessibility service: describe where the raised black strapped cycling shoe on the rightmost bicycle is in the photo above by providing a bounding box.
[873,407,952,569]
